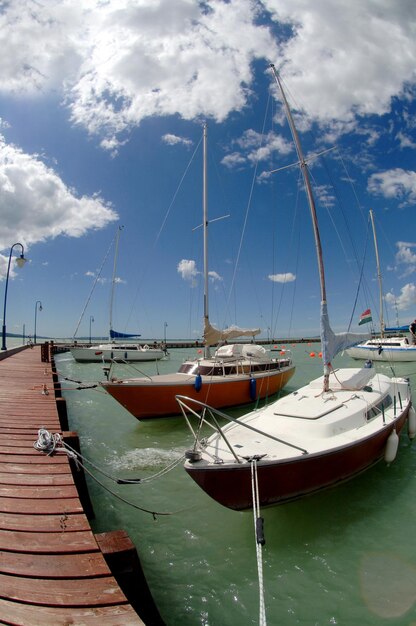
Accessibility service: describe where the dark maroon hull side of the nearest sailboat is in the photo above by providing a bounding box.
[185,408,409,511]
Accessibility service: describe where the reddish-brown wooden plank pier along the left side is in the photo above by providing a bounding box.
[0,346,148,626]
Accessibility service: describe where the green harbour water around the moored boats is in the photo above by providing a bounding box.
[56,345,416,626]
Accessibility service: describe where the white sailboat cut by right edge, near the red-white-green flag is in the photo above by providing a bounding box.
[347,209,416,362]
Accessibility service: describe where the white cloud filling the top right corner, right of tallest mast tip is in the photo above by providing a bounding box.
[263,0,416,122]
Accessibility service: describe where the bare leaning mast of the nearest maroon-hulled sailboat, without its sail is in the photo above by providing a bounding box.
[270,63,330,391]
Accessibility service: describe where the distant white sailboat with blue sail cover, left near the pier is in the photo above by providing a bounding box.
[70,226,166,363]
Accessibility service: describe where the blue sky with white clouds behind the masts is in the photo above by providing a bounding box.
[0,0,416,338]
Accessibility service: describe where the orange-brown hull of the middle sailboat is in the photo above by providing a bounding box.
[101,365,295,419]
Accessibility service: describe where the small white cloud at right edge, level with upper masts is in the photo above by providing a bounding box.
[368,168,416,207]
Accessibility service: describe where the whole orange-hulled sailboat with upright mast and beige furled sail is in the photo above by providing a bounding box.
[101,124,295,419]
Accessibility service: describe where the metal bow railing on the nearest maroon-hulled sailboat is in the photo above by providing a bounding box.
[175,395,308,463]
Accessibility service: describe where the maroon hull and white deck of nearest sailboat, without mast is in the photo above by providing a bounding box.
[184,368,411,510]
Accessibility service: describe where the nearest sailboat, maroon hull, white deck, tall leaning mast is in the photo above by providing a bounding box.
[178,65,416,510]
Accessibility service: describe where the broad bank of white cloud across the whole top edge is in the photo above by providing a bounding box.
[0,0,416,149]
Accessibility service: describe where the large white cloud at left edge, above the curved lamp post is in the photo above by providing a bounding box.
[0,136,118,277]
